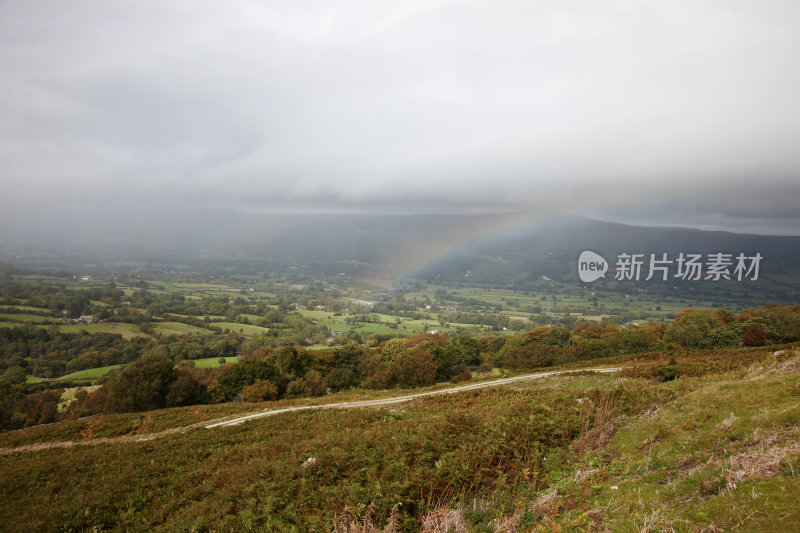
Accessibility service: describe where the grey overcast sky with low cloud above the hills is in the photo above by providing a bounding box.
[0,0,800,234]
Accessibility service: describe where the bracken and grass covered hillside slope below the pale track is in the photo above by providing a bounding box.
[0,353,800,532]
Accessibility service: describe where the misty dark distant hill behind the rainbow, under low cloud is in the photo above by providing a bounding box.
[0,208,800,296]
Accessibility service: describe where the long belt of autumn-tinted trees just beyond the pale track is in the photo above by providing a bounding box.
[0,305,800,429]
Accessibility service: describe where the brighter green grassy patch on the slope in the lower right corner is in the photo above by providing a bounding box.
[580,359,800,531]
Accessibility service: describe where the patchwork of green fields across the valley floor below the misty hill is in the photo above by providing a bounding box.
[0,266,772,350]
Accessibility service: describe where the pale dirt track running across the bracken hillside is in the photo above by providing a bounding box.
[0,367,621,455]
